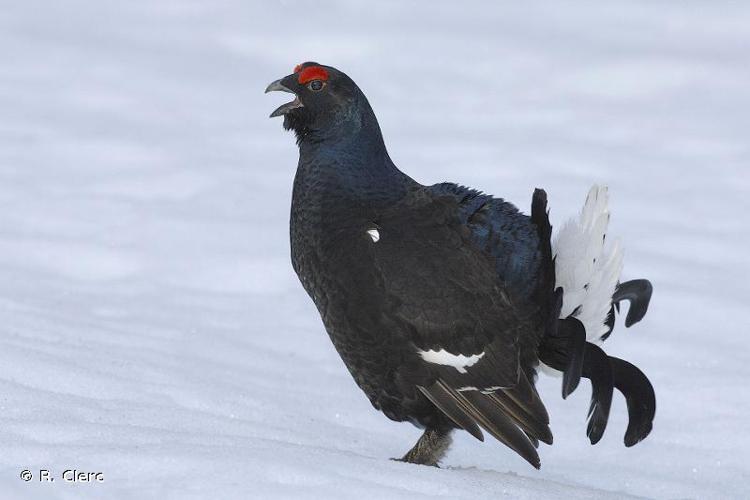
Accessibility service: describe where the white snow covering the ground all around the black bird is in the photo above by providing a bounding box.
[0,0,750,499]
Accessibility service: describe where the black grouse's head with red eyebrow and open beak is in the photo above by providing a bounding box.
[266,62,371,140]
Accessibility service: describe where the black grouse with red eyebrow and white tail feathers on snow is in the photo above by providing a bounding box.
[266,62,656,469]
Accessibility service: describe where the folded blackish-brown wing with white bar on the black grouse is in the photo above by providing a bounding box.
[370,190,552,467]
